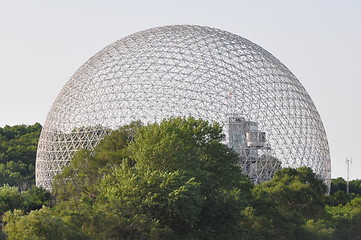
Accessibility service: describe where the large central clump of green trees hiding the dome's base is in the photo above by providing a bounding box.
[49,118,252,239]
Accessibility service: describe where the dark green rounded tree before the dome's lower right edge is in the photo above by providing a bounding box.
[246,167,326,239]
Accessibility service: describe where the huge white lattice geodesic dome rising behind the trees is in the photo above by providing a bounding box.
[36,25,331,189]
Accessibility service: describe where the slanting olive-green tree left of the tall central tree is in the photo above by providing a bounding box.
[53,121,142,202]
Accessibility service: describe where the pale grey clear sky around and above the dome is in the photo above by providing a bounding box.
[0,0,361,179]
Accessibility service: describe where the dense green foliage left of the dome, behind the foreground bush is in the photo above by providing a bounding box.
[0,123,51,239]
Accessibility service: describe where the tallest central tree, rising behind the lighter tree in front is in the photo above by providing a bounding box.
[130,118,251,239]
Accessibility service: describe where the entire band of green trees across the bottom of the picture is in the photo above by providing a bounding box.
[0,118,361,240]
